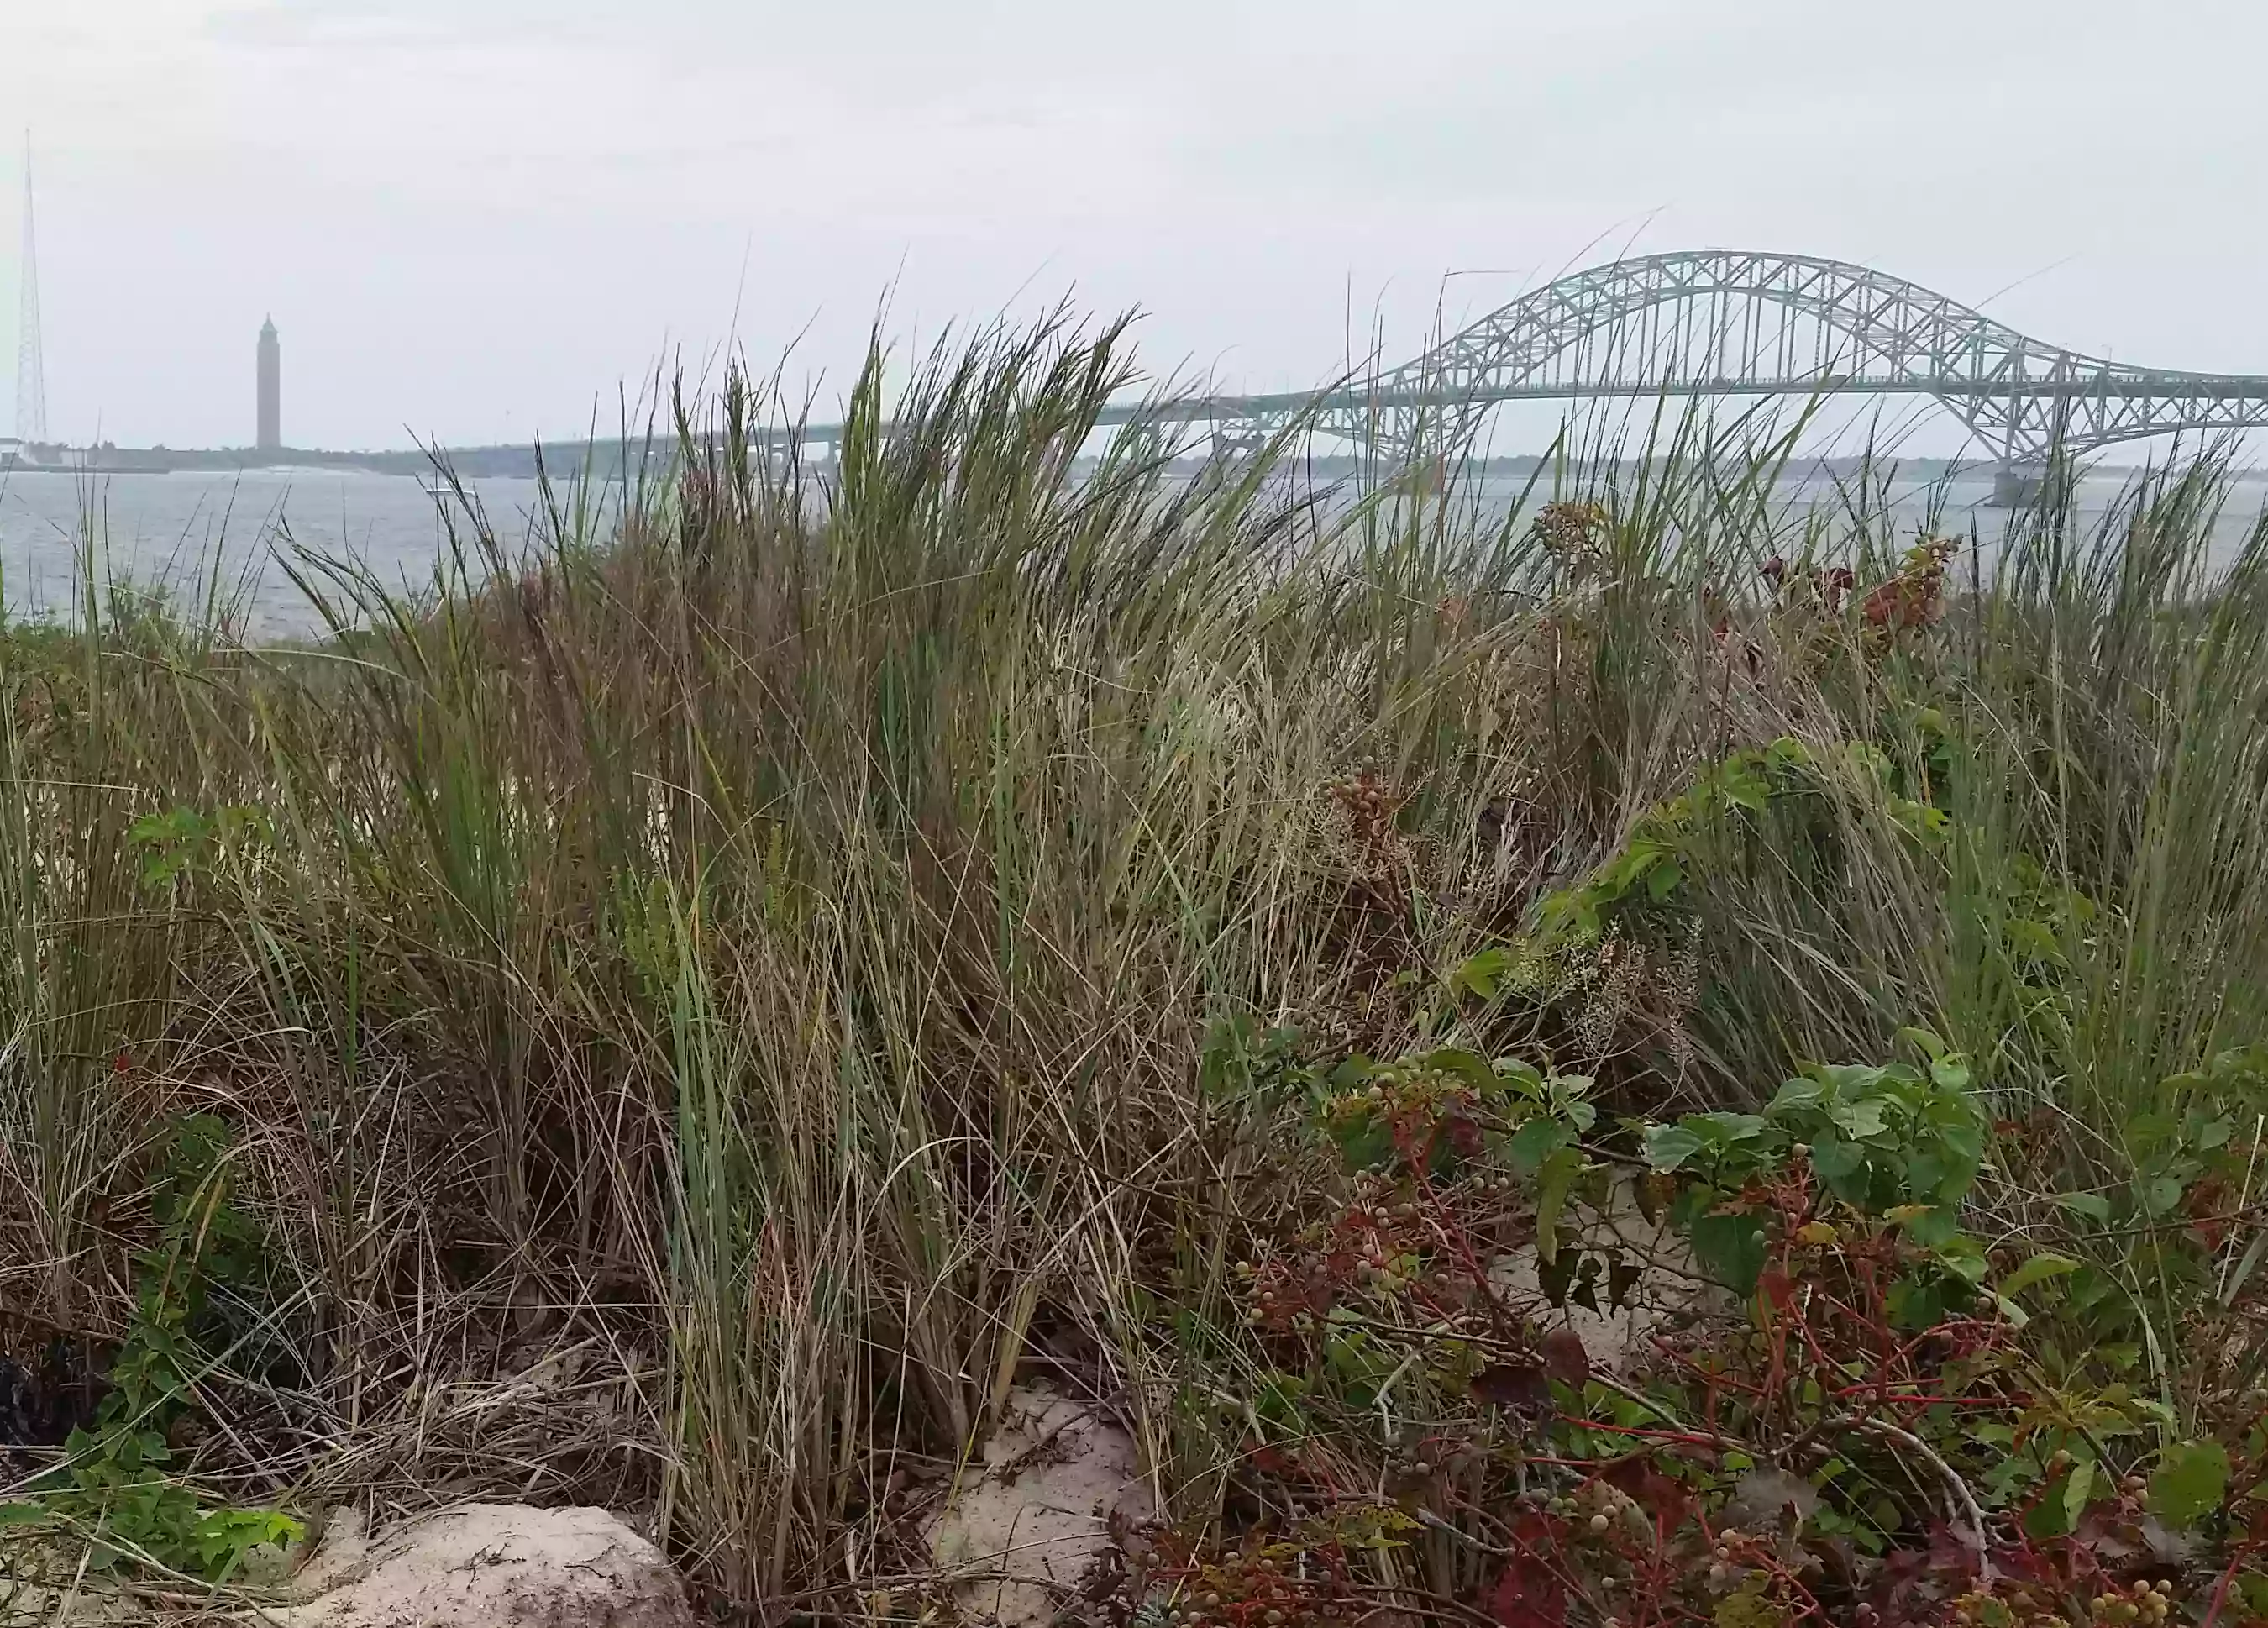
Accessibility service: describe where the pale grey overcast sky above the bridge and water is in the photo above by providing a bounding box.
[0,0,2268,447]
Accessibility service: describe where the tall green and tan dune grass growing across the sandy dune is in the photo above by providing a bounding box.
[0,327,2268,1610]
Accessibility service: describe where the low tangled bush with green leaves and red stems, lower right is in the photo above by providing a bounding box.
[1245,1029,2159,1621]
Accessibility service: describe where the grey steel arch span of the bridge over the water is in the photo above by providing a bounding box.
[1105,249,2268,465]
